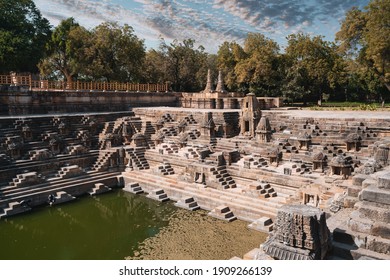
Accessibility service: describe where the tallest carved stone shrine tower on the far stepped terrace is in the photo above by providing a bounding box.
[240,93,261,137]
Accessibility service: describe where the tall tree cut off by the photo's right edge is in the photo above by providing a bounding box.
[336,0,390,99]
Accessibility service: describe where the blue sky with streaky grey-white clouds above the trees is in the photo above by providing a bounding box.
[34,0,369,53]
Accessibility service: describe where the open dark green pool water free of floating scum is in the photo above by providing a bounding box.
[0,190,176,260]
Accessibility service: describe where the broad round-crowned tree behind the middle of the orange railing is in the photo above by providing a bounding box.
[85,22,145,82]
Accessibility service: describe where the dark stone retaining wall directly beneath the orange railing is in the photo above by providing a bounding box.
[0,86,180,115]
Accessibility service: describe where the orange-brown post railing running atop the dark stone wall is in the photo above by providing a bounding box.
[0,75,169,92]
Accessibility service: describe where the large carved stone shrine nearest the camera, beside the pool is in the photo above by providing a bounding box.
[261,205,331,260]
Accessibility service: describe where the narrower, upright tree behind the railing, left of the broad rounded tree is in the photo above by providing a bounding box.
[38,18,90,84]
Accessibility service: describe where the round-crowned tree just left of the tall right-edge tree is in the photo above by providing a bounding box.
[283,33,344,103]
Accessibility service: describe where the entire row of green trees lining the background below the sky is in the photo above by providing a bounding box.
[0,0,390,102]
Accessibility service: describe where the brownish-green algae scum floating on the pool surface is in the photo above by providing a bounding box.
[126,209,267,260]
